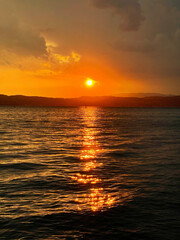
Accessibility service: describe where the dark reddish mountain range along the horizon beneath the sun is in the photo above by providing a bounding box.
[0,95,180,108]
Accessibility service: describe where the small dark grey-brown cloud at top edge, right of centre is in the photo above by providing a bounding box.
[93,0,144,31]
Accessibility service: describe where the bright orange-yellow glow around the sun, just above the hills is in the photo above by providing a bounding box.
[0,49,147,98]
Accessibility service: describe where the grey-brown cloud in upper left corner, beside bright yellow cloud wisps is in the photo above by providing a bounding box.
[0,1,46,57]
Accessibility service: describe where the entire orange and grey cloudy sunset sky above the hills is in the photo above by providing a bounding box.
[0,0,180,98]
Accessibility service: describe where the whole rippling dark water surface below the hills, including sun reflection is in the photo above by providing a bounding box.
[0,107,180,240]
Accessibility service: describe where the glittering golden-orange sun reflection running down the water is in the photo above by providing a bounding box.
[71,108,115,212]
